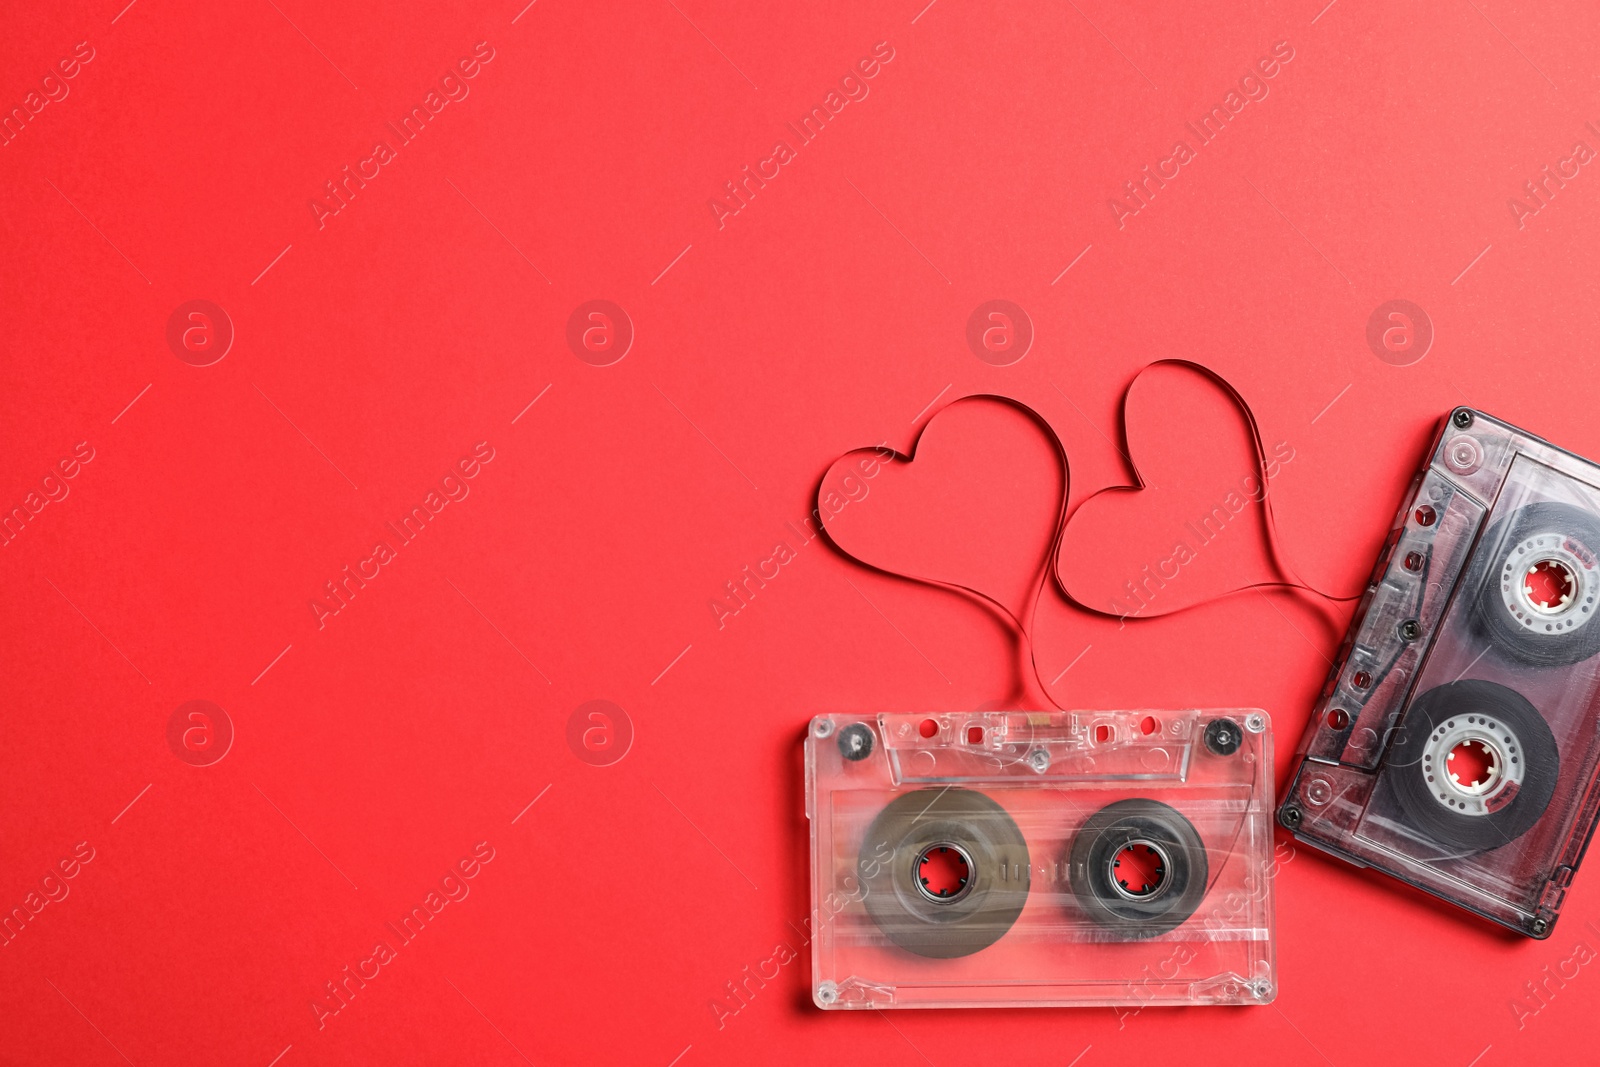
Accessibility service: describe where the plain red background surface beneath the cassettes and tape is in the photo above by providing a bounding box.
[0,0,1600,1067]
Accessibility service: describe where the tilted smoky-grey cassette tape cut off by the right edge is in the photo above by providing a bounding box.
[1278,408,1600,937]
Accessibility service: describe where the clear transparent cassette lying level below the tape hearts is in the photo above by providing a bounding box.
[805,709,1277,1008]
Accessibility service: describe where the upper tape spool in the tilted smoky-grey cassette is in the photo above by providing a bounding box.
[1469,502,1600,667]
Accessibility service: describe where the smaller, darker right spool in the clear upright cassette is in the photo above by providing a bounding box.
[1067,797,1208,941]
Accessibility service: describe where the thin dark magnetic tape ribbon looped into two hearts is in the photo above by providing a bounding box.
[813,358,1362,710]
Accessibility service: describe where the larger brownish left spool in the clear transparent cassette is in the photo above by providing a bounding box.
[858,789,1029,960]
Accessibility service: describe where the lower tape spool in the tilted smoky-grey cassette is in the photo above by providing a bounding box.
[1386,678,1560,854]
